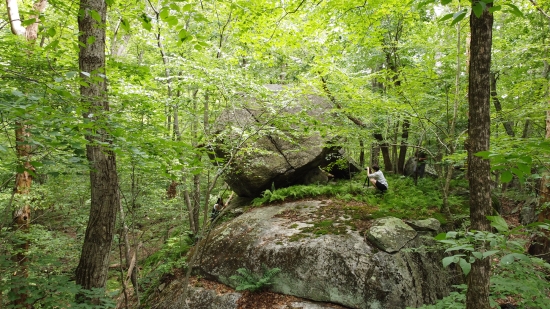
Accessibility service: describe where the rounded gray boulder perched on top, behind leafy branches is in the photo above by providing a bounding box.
[214,85,357,197]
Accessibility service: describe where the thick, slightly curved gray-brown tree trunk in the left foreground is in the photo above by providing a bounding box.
[76,0,120,302]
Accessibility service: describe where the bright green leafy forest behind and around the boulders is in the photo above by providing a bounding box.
[0,0,550,308]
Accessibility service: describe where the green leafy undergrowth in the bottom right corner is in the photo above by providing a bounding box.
[436,216,550,308]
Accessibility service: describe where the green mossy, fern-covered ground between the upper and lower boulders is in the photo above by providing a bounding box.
[254,172,468,241]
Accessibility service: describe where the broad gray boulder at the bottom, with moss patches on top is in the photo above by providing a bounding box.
[196,201,459,309]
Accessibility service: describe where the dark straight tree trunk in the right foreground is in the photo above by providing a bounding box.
[466,1,493,309]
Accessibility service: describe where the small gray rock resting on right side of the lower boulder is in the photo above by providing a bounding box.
[367,217,416,253]
